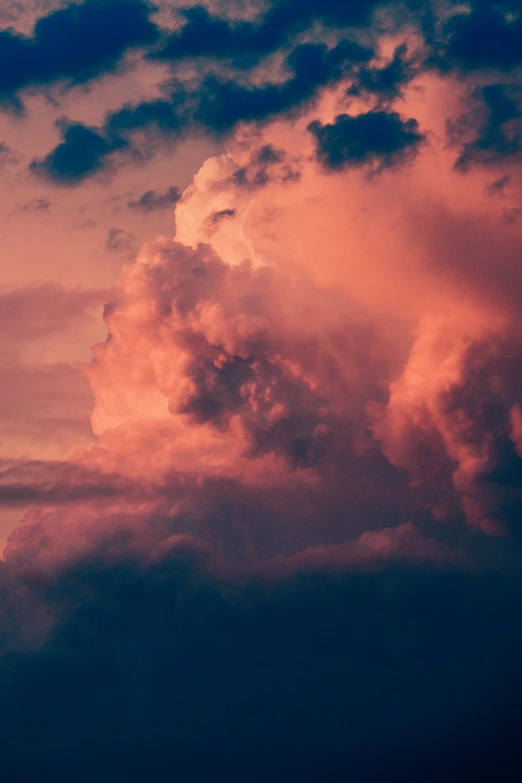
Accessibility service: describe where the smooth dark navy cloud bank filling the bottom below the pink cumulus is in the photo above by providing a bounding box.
[0,547,522,783]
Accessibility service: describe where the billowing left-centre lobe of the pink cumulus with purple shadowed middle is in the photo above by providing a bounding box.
[84,236,378,465]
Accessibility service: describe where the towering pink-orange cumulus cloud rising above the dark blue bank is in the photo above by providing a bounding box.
[8,96,519,563]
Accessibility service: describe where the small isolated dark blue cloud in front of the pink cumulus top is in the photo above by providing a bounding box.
[308,110,425,171]
